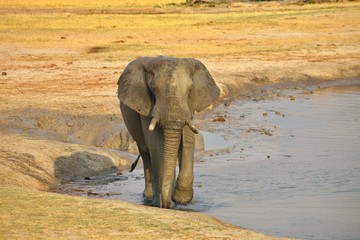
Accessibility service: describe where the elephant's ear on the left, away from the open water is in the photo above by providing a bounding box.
[118,58,151,116]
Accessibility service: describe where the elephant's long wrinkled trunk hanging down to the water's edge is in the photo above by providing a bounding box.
[160,126,182,208]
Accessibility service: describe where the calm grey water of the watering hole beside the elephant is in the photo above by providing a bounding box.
[64,84,360,239]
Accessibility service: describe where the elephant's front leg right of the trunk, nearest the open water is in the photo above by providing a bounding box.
[173,126,195,204]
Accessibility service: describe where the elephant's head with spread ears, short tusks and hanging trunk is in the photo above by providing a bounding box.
[118,57,220,207]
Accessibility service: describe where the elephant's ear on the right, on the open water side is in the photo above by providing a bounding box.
[187,59,220,112]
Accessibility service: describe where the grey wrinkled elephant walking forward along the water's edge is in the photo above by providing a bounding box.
[118,57,220,208]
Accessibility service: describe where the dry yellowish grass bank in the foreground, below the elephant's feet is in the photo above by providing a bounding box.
[0,187,273,239]
